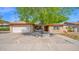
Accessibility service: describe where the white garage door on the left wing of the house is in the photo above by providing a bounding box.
[13,26,31,33]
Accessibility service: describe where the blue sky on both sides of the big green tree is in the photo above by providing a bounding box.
[0,7,79,22]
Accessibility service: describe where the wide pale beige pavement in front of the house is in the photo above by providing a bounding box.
[0,33,79,51]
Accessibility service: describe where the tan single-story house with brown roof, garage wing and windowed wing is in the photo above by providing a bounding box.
[10,22,65,33]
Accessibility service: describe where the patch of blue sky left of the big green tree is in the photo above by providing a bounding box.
[0,7,19,22]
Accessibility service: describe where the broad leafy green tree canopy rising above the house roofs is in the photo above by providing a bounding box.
[17,7,71,24]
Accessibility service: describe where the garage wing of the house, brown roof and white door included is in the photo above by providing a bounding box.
[10,22,33,33]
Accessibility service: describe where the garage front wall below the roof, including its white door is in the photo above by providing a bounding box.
[10,25,33,33]
